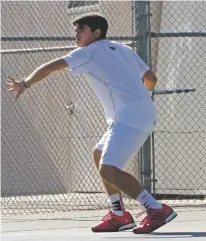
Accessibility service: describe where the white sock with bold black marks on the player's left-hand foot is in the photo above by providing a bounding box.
[109,193,125,216]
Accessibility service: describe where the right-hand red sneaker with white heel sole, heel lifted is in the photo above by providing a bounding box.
[133,204,177,234]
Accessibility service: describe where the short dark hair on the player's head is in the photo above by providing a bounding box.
[73,13,108,39]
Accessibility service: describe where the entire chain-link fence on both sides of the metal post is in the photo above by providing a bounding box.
[1,1,206,215]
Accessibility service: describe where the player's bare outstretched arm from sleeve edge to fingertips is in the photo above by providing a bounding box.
[6,58,68,99]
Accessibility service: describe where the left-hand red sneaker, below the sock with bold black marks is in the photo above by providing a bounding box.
[92,211,136,233]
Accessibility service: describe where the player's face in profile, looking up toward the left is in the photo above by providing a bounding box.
[75,25,97,47]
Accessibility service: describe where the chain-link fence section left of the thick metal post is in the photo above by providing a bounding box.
[2,2,140,214]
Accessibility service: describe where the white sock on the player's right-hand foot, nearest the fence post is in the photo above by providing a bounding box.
[136,189,162,209]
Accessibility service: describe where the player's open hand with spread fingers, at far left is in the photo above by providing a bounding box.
[6,76,26,100]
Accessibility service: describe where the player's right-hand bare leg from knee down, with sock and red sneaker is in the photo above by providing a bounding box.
[99,165,177,234]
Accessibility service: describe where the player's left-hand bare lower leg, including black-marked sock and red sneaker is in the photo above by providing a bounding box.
[92,149,136,232]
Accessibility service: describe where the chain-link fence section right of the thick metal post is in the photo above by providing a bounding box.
[150,1,206,200]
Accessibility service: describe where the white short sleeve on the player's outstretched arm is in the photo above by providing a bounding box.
[62,46,94,74]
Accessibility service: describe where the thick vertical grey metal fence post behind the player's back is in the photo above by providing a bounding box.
[133,1,151,192]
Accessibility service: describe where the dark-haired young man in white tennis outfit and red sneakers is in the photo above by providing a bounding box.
[7,14,177,234]
